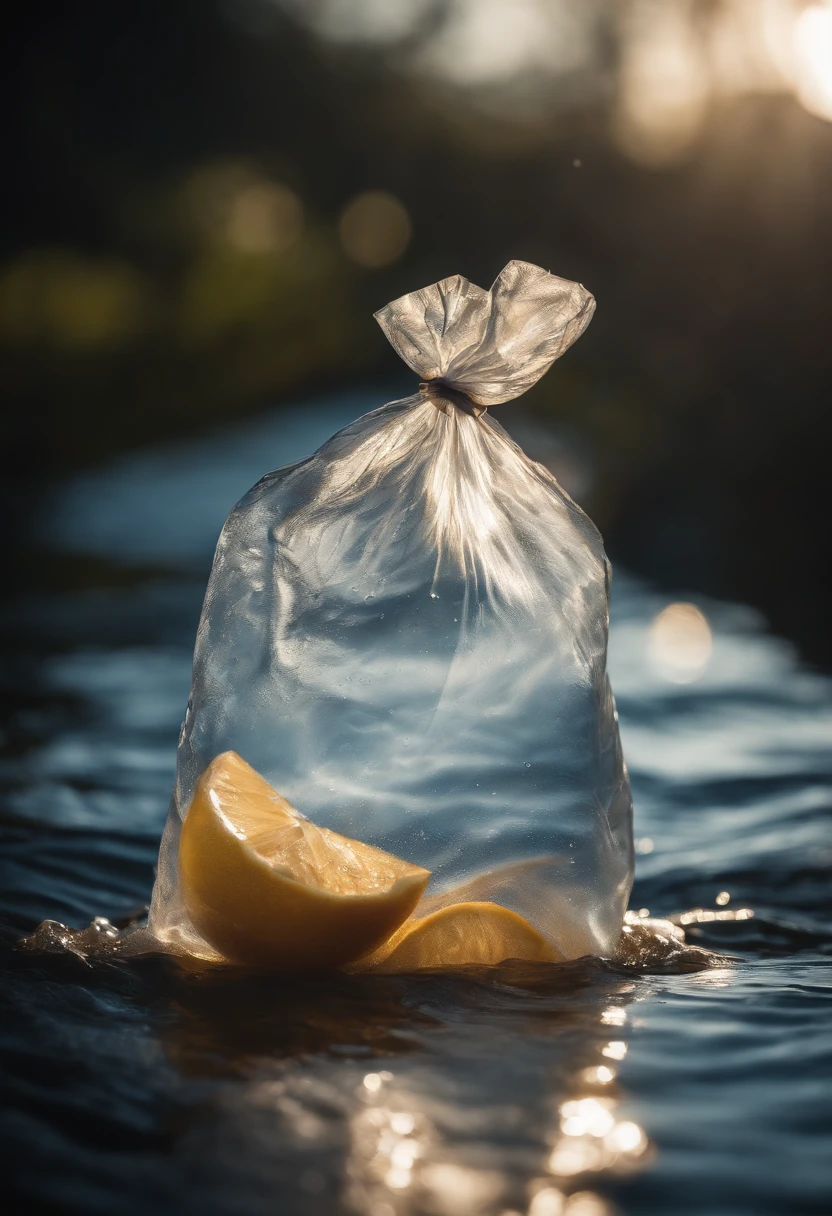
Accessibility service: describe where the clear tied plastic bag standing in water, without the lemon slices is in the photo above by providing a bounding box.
[148,261,633,958]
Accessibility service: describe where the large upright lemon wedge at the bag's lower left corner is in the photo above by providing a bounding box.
[179,751,431,972]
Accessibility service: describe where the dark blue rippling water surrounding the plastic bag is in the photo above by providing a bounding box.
[0,398,832,1216]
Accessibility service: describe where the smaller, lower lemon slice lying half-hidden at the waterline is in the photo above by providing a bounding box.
[359,902,560,972]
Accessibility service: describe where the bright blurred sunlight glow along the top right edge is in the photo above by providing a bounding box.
[280,0,832,147]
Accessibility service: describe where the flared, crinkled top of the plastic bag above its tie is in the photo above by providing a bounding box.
[376,261,595,417]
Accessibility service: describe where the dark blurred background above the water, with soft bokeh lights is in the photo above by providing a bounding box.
[0,0,832,665]
